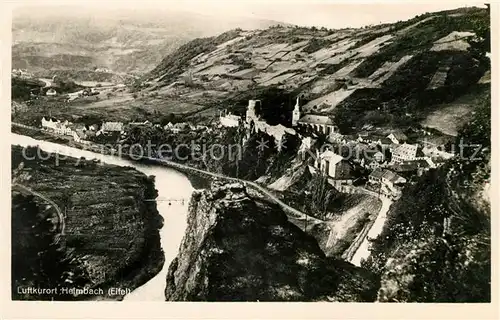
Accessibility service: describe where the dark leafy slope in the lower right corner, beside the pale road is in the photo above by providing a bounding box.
[365,91,491,302]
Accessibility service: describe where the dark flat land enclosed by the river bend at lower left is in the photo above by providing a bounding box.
[12,145,165,300]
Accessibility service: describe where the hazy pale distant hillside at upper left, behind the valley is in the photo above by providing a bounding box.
[12,6,286,75]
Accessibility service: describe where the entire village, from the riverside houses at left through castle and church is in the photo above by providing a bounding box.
[41,92,454,200]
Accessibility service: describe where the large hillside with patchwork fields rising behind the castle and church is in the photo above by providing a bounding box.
[138,8,490,131]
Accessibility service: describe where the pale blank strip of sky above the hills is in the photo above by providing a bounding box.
[8,0,484,28]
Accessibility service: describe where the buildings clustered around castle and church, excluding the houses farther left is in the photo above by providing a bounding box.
[219,98,454,198]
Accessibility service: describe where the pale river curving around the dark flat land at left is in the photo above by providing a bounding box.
[11,133,194,301]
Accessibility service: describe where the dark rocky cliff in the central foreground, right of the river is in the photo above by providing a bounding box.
[165,181,378,301]
